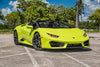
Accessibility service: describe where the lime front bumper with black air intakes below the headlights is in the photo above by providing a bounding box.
[41,38,90,49]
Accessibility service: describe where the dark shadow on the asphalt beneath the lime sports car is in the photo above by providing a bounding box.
[20,44,92,53]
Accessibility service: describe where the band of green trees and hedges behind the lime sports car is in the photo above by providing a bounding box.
[0,0,100,33]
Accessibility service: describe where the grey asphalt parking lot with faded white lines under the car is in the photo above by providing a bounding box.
[0,33,100,67]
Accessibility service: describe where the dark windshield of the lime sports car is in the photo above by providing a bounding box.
[38,21,73,28]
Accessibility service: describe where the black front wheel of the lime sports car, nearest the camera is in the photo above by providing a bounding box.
[32,33,42,50]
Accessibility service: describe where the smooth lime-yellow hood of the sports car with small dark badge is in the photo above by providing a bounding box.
[37,28,89,41]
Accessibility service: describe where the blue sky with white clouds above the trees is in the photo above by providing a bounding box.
[0,0,100,22]
